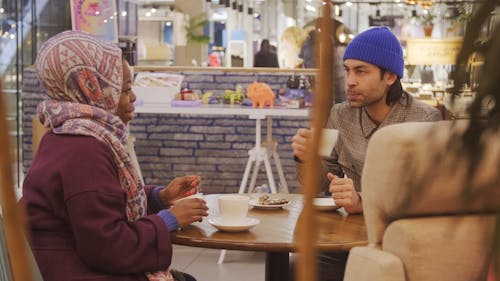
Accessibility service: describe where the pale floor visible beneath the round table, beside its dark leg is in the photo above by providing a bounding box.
[172,245,265,281]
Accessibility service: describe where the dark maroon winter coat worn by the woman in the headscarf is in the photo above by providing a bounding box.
[22,132,172,281]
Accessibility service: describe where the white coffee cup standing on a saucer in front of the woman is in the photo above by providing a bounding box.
[219,194,250,225]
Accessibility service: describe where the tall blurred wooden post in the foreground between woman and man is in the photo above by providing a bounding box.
[297,1,335,281]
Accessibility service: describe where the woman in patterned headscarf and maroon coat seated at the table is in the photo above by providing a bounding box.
[23,31,208,281]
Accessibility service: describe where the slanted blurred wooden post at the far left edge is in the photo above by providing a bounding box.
[0,81,33,281]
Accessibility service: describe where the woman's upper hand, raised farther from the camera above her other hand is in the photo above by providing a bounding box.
[158,175,201,205]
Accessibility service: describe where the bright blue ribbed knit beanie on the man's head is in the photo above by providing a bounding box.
[344,26,405,78]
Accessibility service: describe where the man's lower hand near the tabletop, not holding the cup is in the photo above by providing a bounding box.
[327,173,363,214]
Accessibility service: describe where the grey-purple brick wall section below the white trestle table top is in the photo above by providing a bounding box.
[130,114,307,193]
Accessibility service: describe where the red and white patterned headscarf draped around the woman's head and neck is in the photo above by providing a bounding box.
[35,31,173,281]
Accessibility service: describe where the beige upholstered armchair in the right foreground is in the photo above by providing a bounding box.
[344,121,500,281]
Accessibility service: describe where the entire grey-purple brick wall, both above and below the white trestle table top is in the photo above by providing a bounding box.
[22,66,310,193]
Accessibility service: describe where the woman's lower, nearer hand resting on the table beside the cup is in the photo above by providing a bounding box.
[169,198,208,227]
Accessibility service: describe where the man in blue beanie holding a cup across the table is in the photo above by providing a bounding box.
[292,27,442,280]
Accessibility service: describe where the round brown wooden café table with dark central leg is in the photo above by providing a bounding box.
[171,194,368,280]
